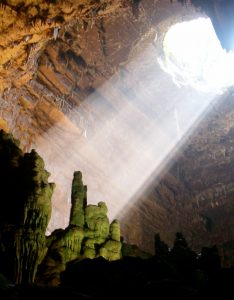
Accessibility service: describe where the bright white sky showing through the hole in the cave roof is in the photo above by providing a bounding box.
[161,18,234,93]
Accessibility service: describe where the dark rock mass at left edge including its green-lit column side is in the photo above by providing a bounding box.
[0,131,54,283]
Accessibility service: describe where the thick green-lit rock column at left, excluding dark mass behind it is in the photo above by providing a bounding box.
[15,150,54,283]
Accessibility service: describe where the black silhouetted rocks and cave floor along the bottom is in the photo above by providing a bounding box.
[0,233,234,300]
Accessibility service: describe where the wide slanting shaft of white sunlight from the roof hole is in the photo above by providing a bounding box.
[35,19,231,230]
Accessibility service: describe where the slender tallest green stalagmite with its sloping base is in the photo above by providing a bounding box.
[37,171,87,285]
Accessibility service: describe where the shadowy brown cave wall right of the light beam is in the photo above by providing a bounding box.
[120,94,234,265]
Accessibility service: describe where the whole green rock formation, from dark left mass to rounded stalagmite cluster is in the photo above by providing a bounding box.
[0,130,121,284]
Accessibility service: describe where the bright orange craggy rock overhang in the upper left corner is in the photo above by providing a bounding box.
[0,0,122,92]
